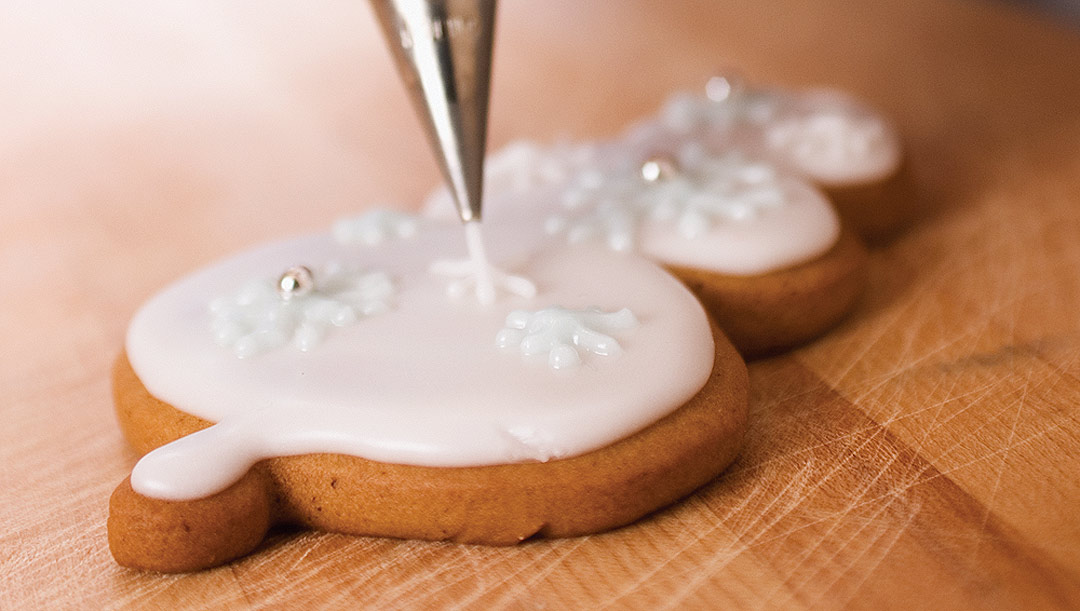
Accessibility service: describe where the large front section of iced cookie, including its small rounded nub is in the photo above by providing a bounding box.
[108,220,747,571]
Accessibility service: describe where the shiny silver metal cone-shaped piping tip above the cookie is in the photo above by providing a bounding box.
[372,0,496,222]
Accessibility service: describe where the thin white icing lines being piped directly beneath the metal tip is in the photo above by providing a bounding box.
[431,221,537,306]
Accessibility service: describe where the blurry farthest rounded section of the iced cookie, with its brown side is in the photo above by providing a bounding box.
[625,74,915,241]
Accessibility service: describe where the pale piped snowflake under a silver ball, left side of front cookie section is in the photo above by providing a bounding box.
[210,264,394,358]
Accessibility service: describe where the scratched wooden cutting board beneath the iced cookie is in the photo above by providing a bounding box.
[0,0,1080,610]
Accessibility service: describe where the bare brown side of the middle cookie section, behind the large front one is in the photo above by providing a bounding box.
[667,229,867,358]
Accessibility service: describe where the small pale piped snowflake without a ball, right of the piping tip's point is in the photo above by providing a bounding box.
[495,307,638,369]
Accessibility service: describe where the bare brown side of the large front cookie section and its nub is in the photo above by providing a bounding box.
[109,324,748,571]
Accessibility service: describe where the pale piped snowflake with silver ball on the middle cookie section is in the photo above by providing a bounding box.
[545,151,787,252]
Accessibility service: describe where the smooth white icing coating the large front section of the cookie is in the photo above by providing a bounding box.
[126,222,714,500]
